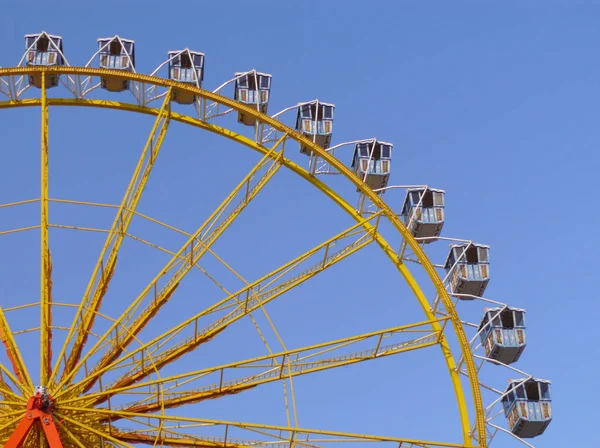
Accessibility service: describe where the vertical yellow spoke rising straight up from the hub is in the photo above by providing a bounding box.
[40,75,52,386]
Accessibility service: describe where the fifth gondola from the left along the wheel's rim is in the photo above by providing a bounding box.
[296,100,335,155]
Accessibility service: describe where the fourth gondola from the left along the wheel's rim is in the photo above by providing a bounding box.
[234,70,272,126]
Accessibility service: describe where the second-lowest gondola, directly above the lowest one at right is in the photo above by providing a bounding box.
[479,307,527,364]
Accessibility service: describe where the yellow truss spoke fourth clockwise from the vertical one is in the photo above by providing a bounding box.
[56,214,379,397]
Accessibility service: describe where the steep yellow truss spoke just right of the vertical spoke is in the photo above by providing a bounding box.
[54,90,171,384]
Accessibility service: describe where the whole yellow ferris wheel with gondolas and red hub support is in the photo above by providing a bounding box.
[0,32,552,448]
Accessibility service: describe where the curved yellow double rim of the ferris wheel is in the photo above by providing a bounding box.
[0,67,487,448]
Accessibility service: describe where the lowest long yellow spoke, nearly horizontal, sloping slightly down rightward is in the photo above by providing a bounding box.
[56,406,466,448]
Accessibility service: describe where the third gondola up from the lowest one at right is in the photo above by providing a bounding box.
[444,243,490,300]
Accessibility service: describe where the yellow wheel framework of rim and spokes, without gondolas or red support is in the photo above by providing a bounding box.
[0,66,490,448]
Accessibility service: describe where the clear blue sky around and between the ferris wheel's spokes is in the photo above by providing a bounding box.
[0,0,600,447]
